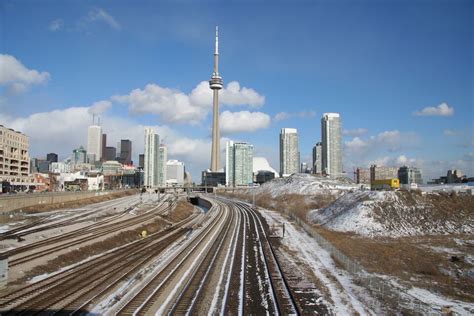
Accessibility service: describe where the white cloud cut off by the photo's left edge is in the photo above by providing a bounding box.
[0,54,50,94]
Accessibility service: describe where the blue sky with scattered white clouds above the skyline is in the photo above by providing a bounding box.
[0,0,474,179]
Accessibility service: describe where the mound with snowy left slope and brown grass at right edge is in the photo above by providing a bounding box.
[308,191,474,237]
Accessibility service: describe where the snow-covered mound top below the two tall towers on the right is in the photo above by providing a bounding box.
[255,173,360,197]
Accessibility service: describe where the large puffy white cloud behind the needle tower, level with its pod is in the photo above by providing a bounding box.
[112,81,265,124]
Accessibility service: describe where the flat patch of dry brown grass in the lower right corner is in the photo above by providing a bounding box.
[315,227,474,302]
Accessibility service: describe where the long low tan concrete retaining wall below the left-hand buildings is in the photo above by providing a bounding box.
[0,190,137,213]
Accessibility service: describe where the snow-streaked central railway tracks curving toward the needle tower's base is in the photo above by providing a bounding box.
[113,196,300,315]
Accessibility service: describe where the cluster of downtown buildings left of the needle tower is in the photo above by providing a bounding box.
[0,118,191,193]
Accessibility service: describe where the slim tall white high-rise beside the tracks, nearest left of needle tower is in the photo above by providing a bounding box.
[143,127,160,187]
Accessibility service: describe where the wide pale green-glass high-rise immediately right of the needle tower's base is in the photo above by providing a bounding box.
[226,141,253,186]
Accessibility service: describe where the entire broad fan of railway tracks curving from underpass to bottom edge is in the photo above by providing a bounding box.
[0,198,301,315]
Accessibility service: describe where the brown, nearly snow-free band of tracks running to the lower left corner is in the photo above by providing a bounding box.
[0,209,202,315]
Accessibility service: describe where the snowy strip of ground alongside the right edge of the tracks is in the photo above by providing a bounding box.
[260,209,379,315]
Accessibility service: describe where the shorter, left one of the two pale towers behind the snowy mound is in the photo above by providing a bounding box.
[280,128,300,177]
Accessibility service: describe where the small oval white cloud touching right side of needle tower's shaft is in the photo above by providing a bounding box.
[219,111,271,134]
